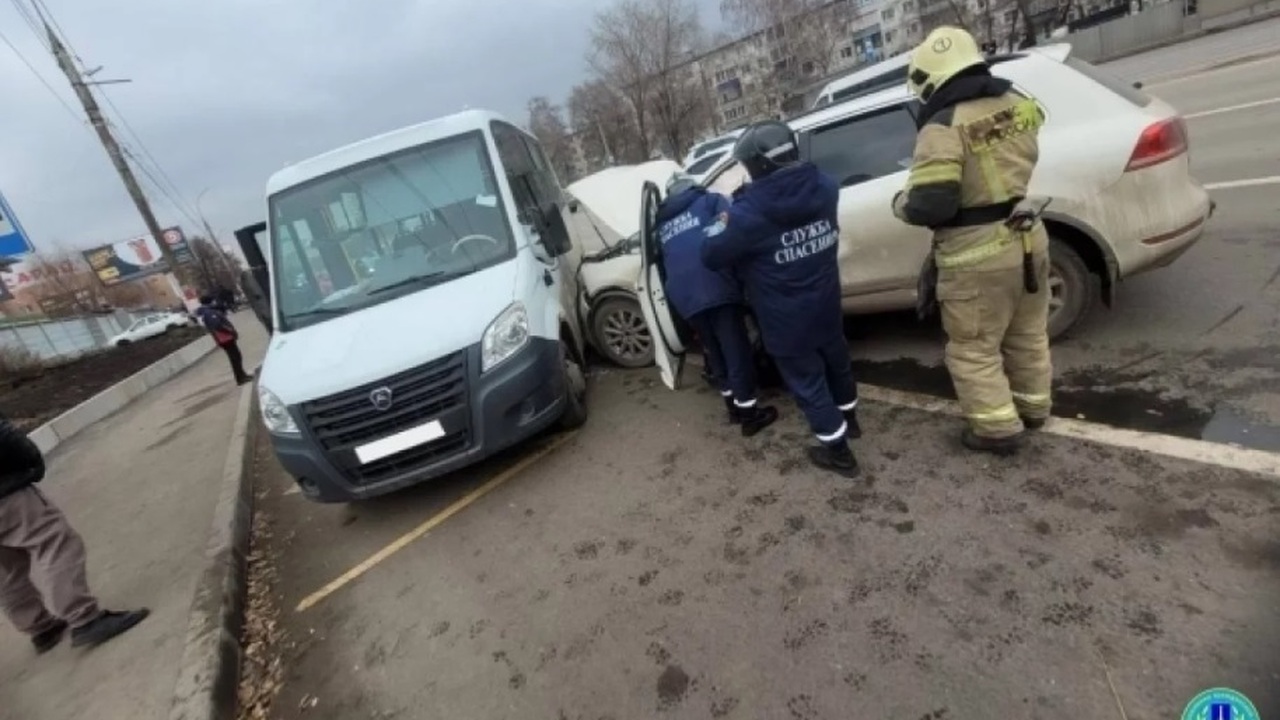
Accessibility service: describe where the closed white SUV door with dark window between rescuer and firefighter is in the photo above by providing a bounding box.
[800,104,932,297]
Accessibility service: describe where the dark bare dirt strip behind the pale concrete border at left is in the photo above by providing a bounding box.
[0,328,204,432]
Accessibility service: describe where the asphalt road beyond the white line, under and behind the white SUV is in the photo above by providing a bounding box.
[851,50,1280,450]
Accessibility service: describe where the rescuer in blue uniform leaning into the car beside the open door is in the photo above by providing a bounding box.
[658,173,778,437]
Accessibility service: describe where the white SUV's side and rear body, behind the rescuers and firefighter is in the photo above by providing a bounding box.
[707,45,1213,337]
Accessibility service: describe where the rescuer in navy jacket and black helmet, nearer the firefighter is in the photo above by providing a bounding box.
[703,120,861,478]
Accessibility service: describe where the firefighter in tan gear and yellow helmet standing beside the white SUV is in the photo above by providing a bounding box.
[893,27,1053,455]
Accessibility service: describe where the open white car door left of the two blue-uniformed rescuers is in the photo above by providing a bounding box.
[636,182,685,389]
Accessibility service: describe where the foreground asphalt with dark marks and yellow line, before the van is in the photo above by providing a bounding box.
[257,370,1280,720]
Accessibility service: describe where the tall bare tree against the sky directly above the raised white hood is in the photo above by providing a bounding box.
[588,0,707,158]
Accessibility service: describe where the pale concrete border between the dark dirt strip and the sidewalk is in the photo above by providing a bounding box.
[27,336,216,455]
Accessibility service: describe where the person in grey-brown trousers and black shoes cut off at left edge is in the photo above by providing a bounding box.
[0,416,150,653]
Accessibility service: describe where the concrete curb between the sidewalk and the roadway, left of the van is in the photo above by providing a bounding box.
[169,383,260,720]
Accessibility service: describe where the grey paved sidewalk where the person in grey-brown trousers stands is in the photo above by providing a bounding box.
[0,313,266,720]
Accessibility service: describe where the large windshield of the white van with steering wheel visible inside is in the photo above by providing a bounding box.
[269,131,515,331]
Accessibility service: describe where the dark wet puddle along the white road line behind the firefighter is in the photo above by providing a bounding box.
[852,357,1280,451]
